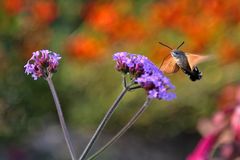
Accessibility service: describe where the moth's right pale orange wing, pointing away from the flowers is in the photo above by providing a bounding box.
[186,53,209,69]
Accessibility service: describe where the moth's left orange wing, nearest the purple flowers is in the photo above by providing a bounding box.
[160,55,179,73]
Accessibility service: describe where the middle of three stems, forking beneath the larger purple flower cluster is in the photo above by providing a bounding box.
[79,79,131,160]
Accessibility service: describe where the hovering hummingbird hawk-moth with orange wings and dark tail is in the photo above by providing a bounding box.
[159,42,208,81]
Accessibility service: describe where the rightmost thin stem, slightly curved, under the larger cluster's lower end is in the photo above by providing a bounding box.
[87,98,151,160]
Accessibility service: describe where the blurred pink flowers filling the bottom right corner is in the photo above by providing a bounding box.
[188,84,240,160]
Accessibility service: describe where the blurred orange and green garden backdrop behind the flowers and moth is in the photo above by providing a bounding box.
[0,0,240,160]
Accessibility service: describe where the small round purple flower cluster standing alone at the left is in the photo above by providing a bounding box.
[24,50,61,80]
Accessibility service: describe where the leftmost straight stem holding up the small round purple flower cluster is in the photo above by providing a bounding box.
[46,78,76,160]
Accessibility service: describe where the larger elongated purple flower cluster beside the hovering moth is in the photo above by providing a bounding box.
[113,52,176,100]
